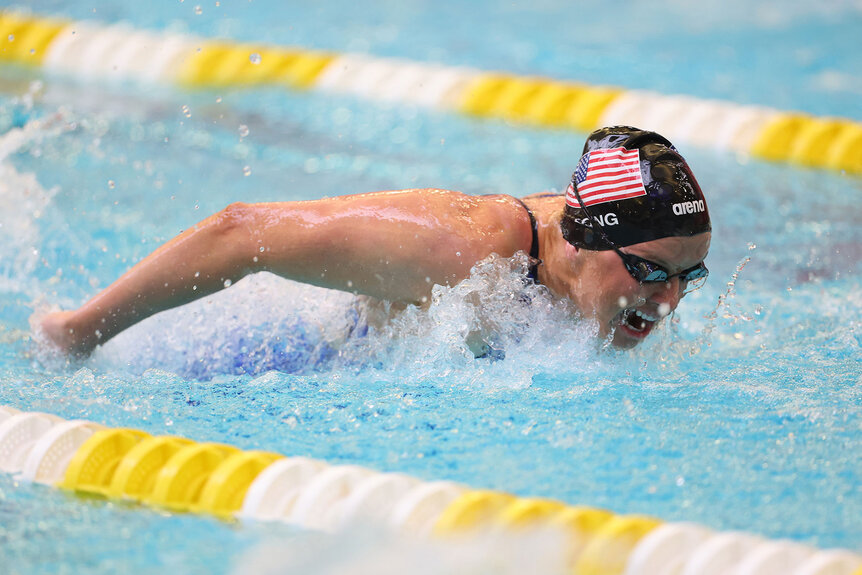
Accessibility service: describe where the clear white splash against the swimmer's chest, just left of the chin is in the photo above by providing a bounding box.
[338,254,595,388]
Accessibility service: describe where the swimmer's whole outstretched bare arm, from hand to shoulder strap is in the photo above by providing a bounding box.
[41,190,530,354]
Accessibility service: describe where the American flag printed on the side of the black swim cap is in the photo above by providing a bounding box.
[566,148,646,208]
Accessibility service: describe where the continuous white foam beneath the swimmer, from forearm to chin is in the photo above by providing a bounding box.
[82,254,608,387]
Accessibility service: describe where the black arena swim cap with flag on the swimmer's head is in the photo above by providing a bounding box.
[560,126,712,250]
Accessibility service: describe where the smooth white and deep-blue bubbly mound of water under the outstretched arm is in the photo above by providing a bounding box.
[94,274,356,379]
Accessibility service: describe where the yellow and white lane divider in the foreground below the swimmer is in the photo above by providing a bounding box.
[0,406,862,575]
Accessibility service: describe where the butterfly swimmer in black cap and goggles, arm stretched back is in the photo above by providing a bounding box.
[39,126,711,356]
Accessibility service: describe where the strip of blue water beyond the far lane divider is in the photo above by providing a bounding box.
[6,0,862,120]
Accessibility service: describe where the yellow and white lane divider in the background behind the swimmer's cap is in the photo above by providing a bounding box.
[0,11,862,174]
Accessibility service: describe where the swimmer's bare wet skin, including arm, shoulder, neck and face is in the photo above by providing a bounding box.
[35,189,710,355]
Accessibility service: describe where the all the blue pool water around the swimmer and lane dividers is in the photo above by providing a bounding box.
[0,1,862,573]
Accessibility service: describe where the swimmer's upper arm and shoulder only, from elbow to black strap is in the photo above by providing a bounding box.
[250,190,531,303]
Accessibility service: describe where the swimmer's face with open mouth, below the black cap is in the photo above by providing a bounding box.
[570,232,711,348]
